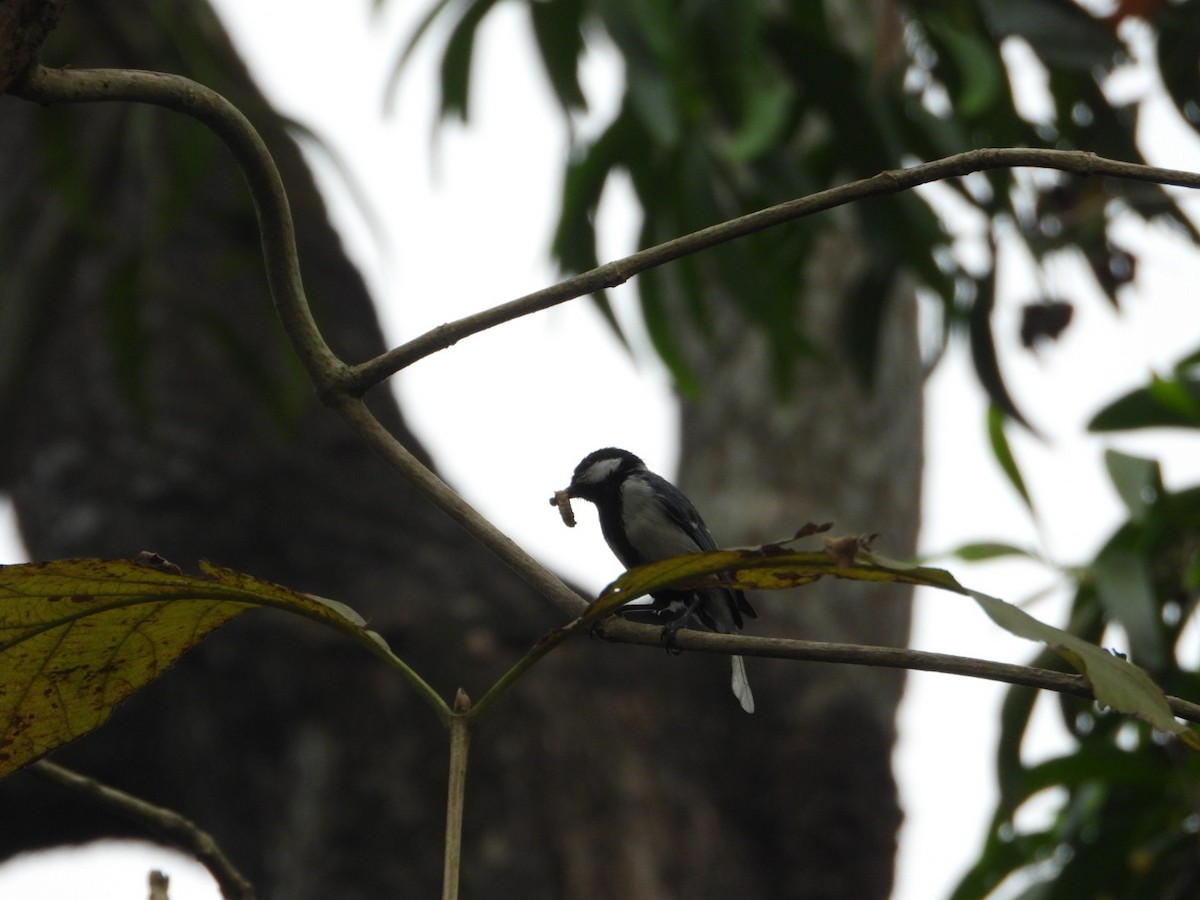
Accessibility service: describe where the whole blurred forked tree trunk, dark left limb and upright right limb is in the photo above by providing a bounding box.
[0,0,919,900]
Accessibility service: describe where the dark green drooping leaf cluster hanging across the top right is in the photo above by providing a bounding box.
[393,0,1200,410]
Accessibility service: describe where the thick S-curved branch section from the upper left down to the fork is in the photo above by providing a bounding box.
[11,66,347,395]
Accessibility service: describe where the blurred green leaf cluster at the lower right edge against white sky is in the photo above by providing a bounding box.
[954,362,1200,900]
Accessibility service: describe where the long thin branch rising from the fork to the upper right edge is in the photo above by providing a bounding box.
[342,148,1200,394]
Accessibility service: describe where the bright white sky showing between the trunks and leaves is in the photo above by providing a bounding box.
[0,0,1200,900]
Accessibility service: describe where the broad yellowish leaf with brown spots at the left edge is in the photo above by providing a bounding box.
[0,559,429,776]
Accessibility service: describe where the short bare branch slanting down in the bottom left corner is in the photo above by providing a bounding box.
[30,760,254,900]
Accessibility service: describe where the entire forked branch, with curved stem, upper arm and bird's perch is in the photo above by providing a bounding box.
[12,67,1200,734]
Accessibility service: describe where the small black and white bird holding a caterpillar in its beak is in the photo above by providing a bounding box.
[566,446,758,713]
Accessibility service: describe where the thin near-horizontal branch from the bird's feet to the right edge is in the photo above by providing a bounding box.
[596,618,1200,722]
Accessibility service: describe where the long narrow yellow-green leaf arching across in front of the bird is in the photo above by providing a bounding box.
[592,539,1200,750]
